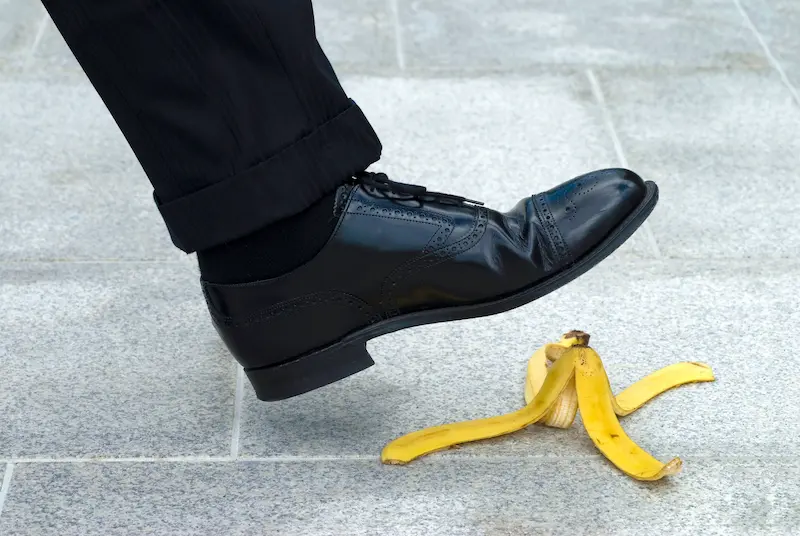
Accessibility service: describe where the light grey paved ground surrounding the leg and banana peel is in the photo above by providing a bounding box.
[0,0,800,536]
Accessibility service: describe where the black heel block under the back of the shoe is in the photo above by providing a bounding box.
[245,342,375,402]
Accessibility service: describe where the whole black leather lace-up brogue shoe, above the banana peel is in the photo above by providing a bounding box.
[203,169,658,400]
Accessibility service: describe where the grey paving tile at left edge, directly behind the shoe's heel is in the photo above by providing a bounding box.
[0,263,234,456]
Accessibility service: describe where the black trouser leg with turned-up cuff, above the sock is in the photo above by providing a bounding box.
[42,0,381,252]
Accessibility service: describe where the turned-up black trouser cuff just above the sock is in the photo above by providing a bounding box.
[154,101,381,253]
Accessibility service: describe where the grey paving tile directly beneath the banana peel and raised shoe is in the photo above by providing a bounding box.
[241,258,800,460]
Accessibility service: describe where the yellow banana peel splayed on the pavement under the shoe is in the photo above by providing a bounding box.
[381,331,714,480]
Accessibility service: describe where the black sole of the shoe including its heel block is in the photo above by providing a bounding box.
[245,181,658,402]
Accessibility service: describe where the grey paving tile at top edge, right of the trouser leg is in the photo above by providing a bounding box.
[400,0,767,72]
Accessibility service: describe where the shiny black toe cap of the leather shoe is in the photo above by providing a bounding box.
[540,169,647,261]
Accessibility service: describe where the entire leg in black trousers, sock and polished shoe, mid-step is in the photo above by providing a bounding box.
[44,0,658,400]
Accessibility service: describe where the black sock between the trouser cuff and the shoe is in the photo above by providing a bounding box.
[197,186,338,284]
